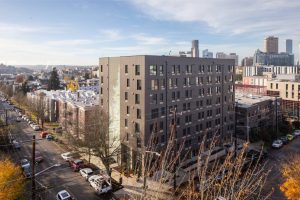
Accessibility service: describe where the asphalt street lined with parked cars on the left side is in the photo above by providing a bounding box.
[4,101,116,200]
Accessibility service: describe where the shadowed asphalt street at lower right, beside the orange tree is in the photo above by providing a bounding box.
[264,136,300,200]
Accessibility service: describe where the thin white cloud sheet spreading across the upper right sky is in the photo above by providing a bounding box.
[131,0,300,35]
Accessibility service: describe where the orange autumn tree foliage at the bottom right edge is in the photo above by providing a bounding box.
[280,155,300,199]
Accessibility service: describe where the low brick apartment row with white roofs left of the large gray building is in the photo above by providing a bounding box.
[27,90,99,139]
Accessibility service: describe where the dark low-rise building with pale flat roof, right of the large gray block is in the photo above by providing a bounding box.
[235,93,281,142]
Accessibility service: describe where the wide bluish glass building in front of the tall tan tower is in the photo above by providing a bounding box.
[253,49,294,66]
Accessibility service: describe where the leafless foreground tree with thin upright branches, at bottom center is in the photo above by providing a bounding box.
[131,130,271,200]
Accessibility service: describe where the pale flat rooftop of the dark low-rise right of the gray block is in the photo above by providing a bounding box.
[235,93,275,108]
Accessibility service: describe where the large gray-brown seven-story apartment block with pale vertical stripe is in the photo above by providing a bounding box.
[99,55,235,169]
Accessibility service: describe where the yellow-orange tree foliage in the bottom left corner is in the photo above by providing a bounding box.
[0,159,25,200]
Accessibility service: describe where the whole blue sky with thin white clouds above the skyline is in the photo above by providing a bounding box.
[0,0,300,65]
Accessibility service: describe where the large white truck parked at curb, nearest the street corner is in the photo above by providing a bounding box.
[88,175,112,194]
